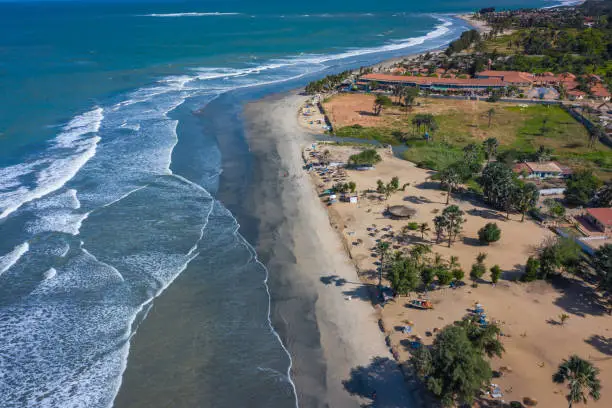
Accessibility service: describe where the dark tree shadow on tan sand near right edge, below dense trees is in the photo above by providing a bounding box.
[550,275,606,317]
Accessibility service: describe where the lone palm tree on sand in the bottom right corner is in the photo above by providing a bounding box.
[553,354,601,408]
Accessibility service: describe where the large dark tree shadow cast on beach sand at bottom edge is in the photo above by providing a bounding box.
[342,357,411,408]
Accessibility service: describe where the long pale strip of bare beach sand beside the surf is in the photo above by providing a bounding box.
[244,93,415,407]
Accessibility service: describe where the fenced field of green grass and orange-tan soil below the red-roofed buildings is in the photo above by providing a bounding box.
[334,95,612,180]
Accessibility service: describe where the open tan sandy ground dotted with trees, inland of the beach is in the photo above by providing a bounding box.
[305,145,612,407]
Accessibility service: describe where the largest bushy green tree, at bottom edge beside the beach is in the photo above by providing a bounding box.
[411,325,492,406]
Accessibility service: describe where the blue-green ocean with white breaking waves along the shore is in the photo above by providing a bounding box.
[0,0,580,408]
